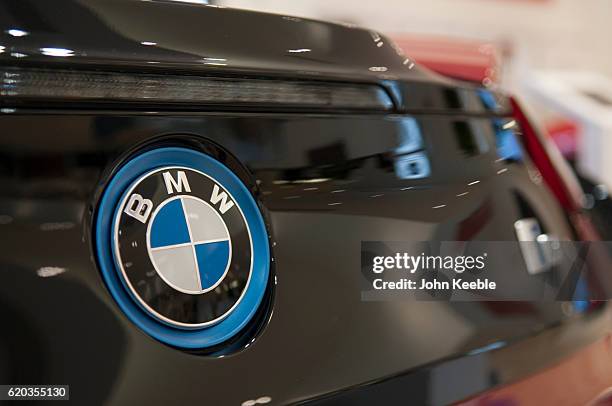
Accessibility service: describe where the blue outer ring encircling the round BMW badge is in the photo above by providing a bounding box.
[94,147,270,349]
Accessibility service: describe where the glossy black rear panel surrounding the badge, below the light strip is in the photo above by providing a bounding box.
[0,112,604,404]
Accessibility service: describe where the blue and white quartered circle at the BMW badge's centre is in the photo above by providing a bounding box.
[149,196,230,294]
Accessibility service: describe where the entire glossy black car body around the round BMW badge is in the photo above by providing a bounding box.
[0,0,610,405]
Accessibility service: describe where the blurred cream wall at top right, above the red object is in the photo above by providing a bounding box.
[217,0,612,84]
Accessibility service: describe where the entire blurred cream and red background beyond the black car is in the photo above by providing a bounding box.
[210,0,612,225]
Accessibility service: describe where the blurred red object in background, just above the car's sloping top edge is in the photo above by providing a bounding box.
[391,34,501,85]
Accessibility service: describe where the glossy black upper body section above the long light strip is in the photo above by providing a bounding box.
[0,0,507,113]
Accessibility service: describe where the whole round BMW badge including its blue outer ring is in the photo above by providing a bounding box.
[96,147,270,348]
